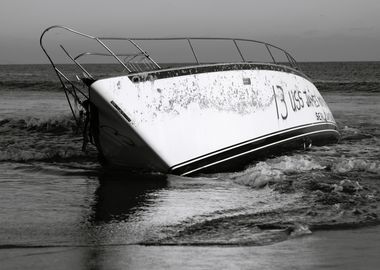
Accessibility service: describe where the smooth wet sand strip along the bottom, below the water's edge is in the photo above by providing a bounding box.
[0,226,380,270]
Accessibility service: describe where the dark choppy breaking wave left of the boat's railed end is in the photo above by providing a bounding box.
[0,115,93,162]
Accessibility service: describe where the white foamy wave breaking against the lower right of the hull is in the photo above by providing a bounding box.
[216,151,380,188]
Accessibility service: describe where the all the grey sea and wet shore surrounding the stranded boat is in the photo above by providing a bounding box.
[0,62,380,269]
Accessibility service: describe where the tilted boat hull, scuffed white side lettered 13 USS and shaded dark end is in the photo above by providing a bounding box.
[90,64,339,174]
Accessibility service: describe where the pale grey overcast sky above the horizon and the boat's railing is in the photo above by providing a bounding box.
[0,0,380,64]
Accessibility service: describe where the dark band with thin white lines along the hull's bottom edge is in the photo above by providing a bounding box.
[170,124,340,175]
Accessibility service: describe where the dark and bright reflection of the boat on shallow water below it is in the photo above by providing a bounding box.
[85,170,310,246]
